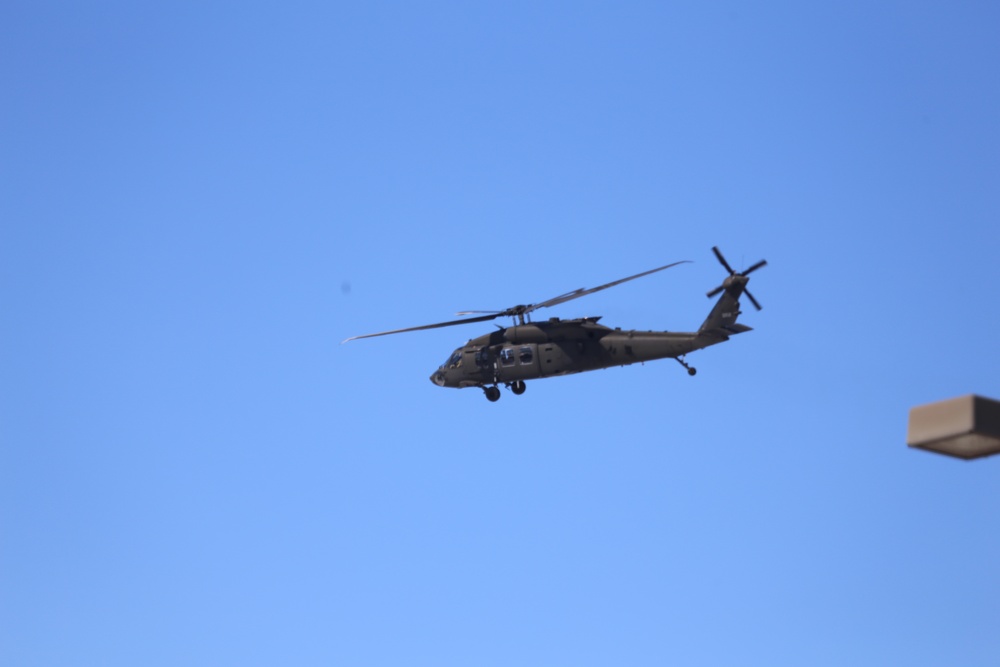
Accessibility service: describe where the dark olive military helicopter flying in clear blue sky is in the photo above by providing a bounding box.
[343,247,767,402]
